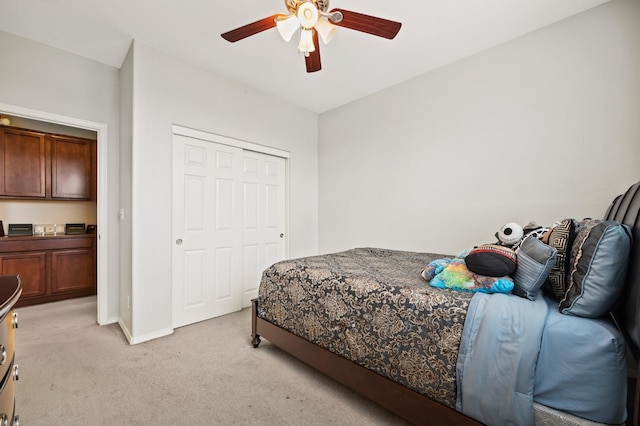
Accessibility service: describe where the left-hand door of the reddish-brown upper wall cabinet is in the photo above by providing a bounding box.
[0,128,47,198]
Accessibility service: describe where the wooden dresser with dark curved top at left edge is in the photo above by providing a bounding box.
[0,275,22,426]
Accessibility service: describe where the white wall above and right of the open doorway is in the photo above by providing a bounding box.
[0,31,119,319]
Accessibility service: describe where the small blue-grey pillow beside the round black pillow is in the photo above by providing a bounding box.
[512,235,558,300]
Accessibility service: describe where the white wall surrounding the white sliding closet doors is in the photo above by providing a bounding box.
[122,41,318,343]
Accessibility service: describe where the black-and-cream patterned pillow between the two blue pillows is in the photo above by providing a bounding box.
[544,219,576,300]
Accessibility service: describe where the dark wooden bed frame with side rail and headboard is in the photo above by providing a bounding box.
[251,182,640,426]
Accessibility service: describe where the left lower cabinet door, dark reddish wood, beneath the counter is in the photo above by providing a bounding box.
[0,252,47,300]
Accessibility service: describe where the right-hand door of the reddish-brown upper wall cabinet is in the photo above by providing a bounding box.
[51,135,92,200]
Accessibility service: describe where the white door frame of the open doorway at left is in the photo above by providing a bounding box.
[0,103,112,325]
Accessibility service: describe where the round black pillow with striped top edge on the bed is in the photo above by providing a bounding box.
[464,244,517,277]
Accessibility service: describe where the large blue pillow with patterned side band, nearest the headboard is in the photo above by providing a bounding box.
[559,219,632,318]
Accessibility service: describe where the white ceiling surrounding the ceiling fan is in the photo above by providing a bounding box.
[0,0,608,113]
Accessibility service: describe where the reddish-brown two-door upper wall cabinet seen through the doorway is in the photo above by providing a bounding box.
[0,127,96,200]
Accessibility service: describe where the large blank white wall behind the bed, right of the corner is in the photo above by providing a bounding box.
[319,0,640,253]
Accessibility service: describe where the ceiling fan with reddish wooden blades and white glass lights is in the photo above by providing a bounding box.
[221,0,402,72]
